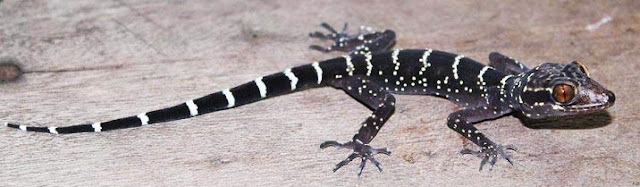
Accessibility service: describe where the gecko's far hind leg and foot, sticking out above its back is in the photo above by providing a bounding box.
[309,23,396,54]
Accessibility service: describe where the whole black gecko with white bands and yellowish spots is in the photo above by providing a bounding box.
[5,23,615,176]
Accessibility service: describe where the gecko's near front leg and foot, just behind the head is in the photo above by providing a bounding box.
[447,106,516,170]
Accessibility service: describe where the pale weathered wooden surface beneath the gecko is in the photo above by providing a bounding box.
[0,0,640,186]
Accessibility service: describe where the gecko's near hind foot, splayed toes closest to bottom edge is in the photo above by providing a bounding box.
[320,141,391,177]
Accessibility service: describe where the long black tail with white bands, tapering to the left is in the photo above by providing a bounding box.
[5,58,344,134]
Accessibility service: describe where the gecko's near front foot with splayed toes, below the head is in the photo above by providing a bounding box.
[460,143,518,171]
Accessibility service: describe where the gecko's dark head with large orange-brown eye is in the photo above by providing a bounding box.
[516,61,615,118]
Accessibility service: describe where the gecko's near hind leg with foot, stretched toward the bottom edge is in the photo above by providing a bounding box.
[320,76,396,176]
